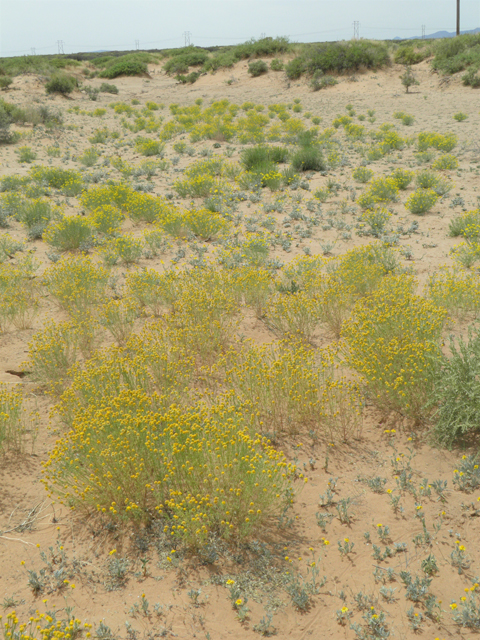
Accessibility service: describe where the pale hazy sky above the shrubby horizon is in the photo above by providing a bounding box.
[0,0,480,56]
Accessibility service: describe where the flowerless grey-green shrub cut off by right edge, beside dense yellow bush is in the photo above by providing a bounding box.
[432,327,480,447]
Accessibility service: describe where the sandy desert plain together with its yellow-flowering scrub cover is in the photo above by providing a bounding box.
[0,52,480,640]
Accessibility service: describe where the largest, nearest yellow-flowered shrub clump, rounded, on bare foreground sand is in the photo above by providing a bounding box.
[45,382,294,546]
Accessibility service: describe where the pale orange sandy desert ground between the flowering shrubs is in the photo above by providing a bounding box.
[0,51,480,640]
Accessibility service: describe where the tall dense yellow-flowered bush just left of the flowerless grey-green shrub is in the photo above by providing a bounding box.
[342,275,446,423]
